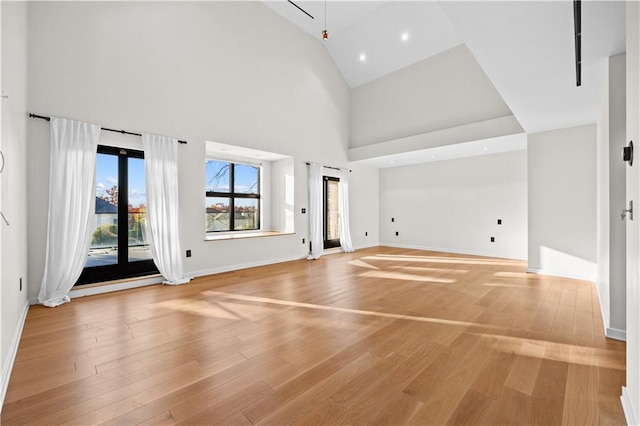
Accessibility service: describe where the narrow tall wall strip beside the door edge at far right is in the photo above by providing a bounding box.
[596,54,626,338]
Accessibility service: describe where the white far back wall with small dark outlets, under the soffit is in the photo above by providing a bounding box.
[380,151,527,259]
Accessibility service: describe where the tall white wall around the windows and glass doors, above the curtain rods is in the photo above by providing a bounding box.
[28,2,350,297]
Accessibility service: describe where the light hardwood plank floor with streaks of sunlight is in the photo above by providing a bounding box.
[2,247,625,425]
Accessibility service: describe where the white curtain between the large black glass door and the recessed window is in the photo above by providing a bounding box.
[142,134,190,285]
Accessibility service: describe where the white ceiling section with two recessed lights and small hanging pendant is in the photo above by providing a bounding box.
[265,0,464,87]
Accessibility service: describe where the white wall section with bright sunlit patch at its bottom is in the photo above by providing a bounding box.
[528,125,597,281]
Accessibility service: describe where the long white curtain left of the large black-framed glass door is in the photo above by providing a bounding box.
[38,117,101,308]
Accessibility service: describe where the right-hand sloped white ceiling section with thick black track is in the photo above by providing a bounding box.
[442,1,625,133]
